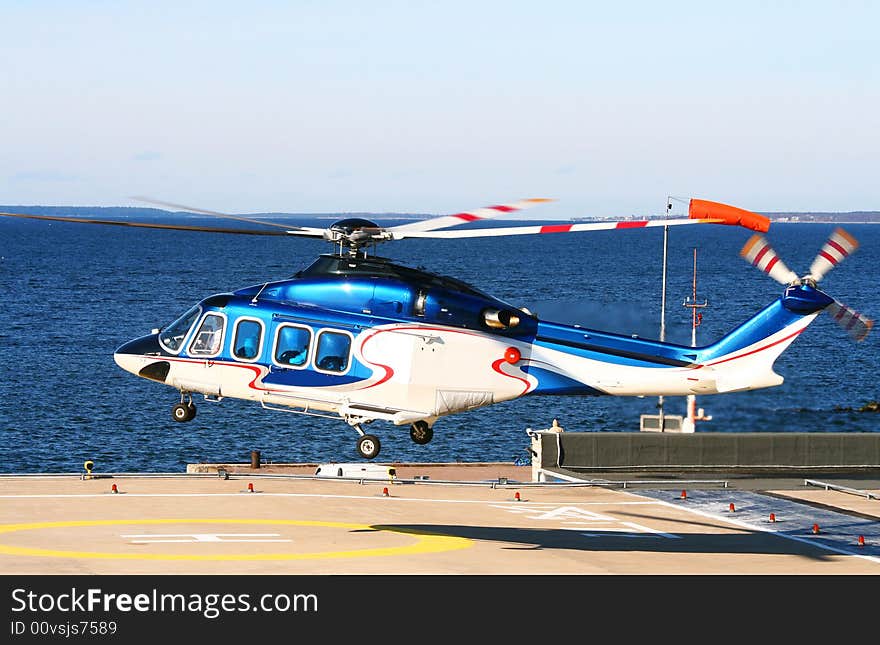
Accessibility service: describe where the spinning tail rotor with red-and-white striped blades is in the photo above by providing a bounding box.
[740,228,874,342]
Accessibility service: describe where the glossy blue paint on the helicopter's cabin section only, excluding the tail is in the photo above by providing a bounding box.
[117,255,537,387]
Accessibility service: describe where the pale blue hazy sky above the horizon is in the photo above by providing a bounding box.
[0,0,880,219]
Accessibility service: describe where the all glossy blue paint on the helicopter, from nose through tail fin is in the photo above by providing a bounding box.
[117,255,833,402]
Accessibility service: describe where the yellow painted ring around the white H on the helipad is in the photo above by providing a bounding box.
[0,519,473,560]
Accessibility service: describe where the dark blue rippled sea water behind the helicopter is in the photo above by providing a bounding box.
[0,217,880,473]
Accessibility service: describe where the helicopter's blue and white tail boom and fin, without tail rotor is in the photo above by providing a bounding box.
[525,285,834,396]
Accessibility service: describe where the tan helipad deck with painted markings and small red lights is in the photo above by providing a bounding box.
[0,464,880,575]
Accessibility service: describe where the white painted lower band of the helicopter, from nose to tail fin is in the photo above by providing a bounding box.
[115,314,815,425]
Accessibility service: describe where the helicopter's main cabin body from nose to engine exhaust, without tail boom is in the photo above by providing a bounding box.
[115,255,538,424]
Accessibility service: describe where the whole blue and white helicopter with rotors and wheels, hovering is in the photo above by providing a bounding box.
[0,198,873,459]
